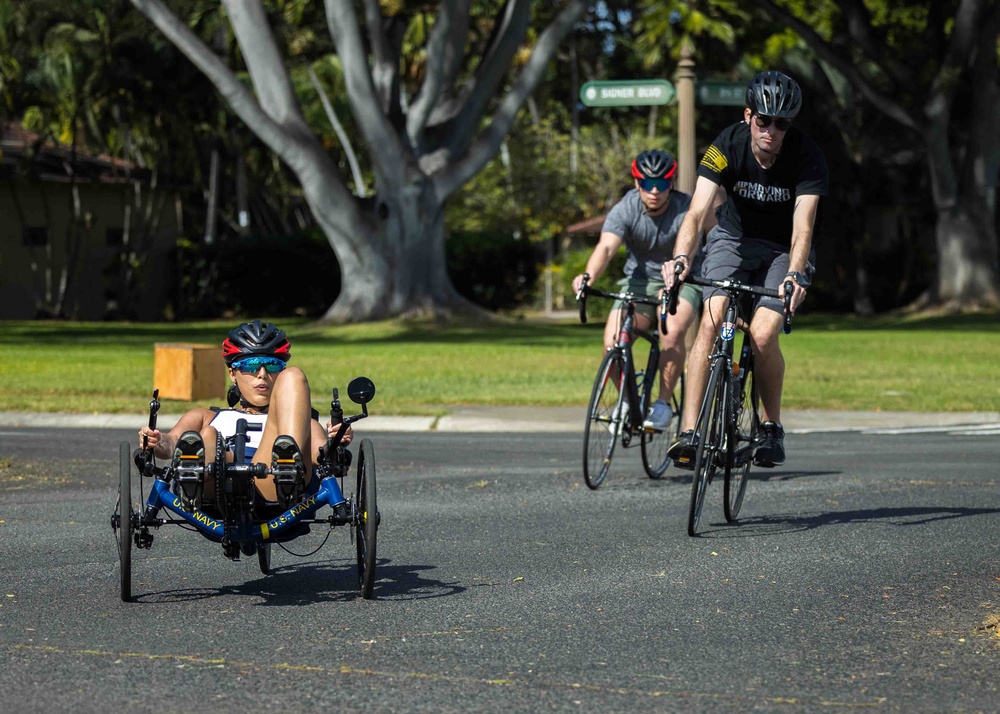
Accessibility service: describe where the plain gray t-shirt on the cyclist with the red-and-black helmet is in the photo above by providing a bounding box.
[602,188,691,280]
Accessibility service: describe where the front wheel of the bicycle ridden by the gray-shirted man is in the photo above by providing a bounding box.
[583,350,625,489]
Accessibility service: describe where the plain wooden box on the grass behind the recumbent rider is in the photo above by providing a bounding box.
[153,342,226,402]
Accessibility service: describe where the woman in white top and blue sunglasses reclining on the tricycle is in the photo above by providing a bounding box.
[139,320,353,518]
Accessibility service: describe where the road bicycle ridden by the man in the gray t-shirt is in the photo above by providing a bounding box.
[576,280,684,489]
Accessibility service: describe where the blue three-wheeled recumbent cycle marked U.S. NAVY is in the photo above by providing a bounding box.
[111,377,380,602]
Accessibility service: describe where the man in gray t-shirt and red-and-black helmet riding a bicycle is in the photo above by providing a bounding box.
[573,149,701,430]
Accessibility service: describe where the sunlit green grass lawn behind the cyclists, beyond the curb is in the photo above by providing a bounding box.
[0,314,1000,414]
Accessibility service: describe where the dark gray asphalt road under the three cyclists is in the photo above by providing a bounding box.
[0,428,1000,712]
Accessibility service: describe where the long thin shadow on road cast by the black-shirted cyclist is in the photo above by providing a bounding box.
[701,506,1000,538]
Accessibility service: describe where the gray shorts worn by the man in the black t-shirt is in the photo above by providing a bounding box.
[701,226,816,312]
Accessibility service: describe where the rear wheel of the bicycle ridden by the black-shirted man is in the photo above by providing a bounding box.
[723,353,760,523]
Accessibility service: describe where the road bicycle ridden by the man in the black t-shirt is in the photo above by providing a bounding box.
[668,276,793,536]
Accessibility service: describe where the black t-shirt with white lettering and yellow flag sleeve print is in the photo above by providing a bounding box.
[698,122,830,246]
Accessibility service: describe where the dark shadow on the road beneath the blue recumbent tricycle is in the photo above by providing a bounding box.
[133,560,466,607]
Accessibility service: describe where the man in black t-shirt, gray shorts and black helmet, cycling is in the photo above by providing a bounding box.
[662,71,829,468]
